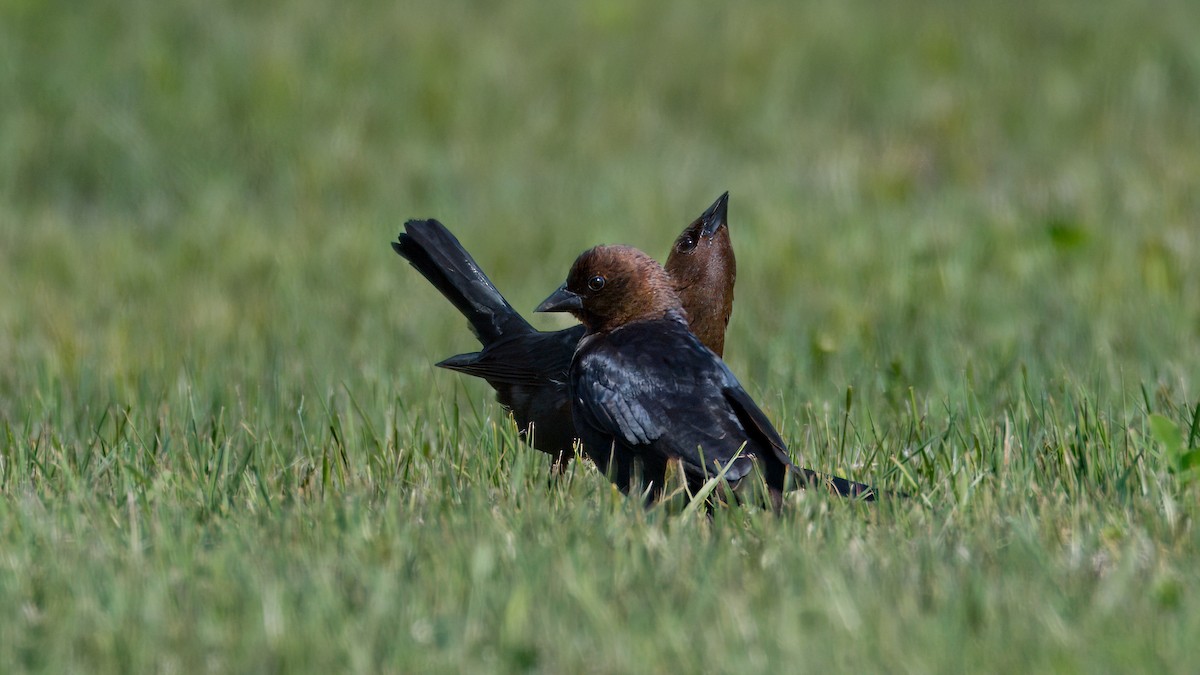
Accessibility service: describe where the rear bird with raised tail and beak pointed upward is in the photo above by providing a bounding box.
[391,192,737,473]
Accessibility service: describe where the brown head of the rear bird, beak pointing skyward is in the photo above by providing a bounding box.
[666,192,737,356]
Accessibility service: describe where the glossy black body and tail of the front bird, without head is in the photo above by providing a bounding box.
[570,313,874,498]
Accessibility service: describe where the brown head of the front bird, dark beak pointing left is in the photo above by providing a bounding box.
[534,246,683,333]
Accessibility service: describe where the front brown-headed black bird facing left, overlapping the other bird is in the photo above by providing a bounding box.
[535,245,876,509]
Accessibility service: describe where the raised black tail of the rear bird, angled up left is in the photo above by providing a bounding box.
[391,220,534,346]
